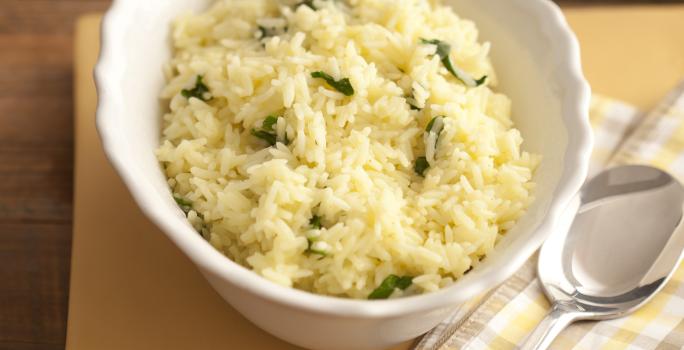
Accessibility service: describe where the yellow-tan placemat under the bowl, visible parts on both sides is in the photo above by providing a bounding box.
[67,5,684,350]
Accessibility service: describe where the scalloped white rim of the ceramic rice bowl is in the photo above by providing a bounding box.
[95,0,593,318]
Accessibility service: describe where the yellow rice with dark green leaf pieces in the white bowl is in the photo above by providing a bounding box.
[157,0,539,298]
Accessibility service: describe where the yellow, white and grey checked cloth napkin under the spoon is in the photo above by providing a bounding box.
[415,82,684,350]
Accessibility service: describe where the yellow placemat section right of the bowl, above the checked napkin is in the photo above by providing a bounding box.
[565,5,684,110]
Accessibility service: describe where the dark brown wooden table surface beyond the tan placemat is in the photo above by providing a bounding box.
[0,0,682,350]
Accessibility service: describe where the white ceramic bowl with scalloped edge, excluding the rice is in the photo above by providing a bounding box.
[96,0,592,350]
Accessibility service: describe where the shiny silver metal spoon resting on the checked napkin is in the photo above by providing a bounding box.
[522,166,684,349]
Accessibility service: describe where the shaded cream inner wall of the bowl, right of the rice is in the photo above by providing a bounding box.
[447,0,568,264]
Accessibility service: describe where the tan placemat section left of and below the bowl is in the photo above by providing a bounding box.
[67,16,306,350]
